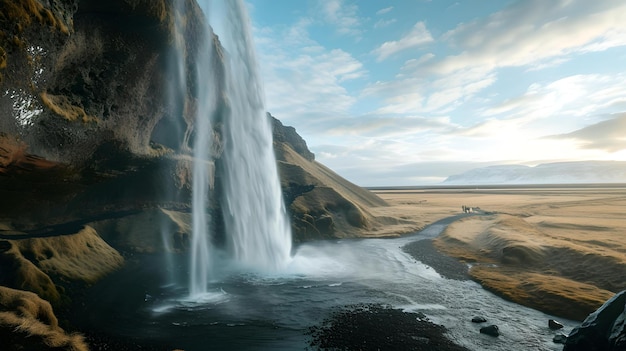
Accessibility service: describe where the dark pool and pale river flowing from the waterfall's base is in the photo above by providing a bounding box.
[73,219,577,351]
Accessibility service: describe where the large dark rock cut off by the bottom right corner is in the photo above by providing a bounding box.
[563,290,626,351]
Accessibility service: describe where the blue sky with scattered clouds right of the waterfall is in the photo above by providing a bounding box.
[246,0,626,186]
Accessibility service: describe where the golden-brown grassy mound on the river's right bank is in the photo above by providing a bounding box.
[428,199,626,320]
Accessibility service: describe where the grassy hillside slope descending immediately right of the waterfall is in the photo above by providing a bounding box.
[275,143,419,241]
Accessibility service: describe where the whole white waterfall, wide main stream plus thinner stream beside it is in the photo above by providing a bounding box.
[183,0,291,298]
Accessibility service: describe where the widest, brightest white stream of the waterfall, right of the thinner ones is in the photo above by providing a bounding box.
[207,0,291,271]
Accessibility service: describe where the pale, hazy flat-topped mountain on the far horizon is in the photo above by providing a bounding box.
[443,161,626,185]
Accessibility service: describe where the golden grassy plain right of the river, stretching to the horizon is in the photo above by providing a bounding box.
[376,186,626,320]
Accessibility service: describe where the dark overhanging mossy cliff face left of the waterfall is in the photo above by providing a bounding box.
[0,0,206,228]
